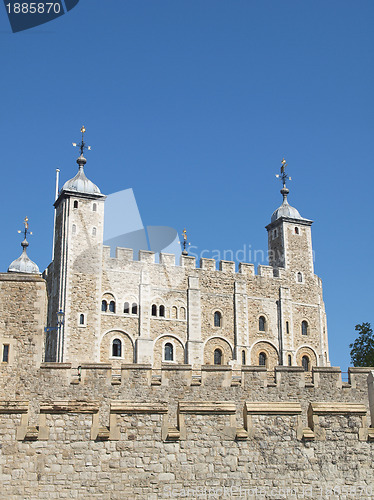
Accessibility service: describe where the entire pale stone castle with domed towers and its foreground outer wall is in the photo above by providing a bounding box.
[0,139,374,499]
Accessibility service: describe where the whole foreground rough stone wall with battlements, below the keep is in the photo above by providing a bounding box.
[0,364,374,500]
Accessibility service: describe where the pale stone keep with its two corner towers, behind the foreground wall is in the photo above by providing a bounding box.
[45,162,329,371]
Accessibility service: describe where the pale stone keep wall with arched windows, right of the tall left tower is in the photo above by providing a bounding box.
[93,252,328,366]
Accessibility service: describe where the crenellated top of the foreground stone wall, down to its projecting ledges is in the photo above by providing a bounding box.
[0,363,374,441]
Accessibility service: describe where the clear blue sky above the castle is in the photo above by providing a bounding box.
[0,0,374,370]
